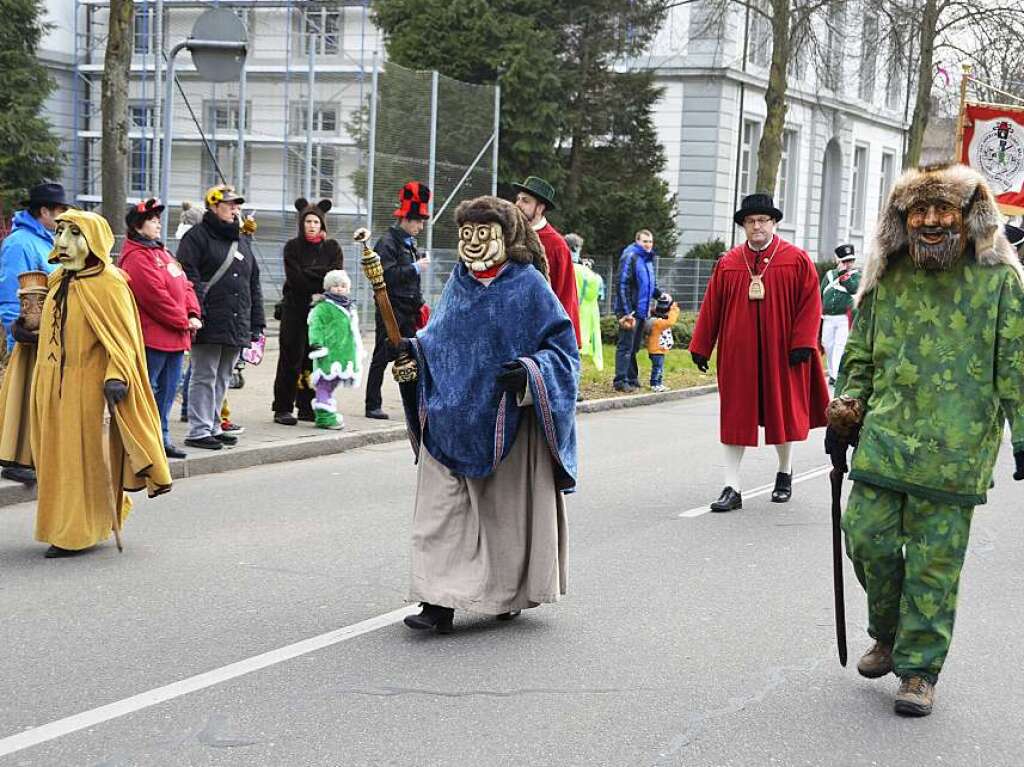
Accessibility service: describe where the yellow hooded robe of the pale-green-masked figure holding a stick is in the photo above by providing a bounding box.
[30,210,171,550]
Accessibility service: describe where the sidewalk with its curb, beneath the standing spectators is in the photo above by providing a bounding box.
[0,322,717,506]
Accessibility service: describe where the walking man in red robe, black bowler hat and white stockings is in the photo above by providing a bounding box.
[690,195,828,511]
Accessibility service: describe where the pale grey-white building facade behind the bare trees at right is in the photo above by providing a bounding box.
[635,2,910,260]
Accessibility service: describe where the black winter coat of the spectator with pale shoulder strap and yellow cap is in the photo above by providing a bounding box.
[176,206,266,348]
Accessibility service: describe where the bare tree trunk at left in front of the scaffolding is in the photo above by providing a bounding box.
[100,0,135,233]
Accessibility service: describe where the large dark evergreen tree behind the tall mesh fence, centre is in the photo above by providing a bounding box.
[374,0,676,254]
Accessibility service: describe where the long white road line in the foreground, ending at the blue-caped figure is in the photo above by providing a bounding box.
[0,604,419,757]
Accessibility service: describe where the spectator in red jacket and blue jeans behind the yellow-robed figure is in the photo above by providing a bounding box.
[119,198,203,458]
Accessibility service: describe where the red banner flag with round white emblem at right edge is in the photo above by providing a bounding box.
[959,103,1024,216]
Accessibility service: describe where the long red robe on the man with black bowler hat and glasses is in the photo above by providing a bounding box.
[690,235,828,446]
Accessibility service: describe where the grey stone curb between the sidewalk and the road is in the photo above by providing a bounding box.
[0,384,718,507]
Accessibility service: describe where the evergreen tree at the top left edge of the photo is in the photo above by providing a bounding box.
[0,0,62,215]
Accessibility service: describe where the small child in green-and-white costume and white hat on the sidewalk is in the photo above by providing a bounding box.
[307,269,362,429]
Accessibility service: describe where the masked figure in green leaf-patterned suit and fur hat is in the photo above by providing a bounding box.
[825,166,1024,716]
